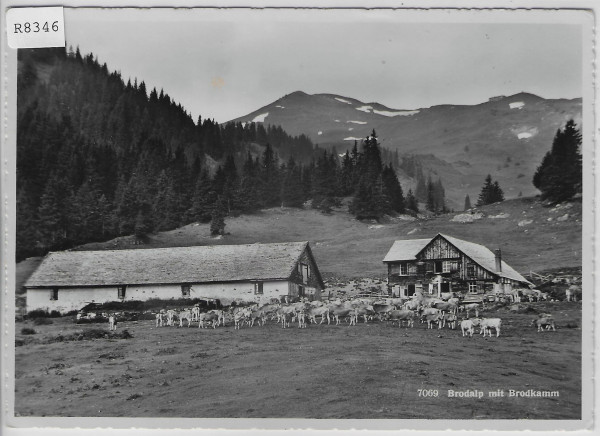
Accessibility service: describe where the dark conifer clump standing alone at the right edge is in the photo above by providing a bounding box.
[533,120,582,203]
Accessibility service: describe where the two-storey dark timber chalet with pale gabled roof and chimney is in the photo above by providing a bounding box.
[383,233,533,297]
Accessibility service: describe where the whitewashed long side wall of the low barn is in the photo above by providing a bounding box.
[27,280,289,313]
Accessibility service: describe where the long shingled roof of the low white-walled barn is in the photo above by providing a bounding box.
[25,242,312,288]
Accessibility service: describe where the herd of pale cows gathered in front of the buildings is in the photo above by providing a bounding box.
[143,292,556,337]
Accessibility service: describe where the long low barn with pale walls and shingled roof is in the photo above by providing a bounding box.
[25,242,325,313]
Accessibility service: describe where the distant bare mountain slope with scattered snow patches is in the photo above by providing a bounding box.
[232,91,582,209]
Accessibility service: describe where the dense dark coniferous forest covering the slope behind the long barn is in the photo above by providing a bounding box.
[17,48,422,260]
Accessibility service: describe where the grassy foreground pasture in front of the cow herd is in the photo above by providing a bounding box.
[15,303,581,419]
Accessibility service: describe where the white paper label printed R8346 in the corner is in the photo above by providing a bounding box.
[6,7,65,48]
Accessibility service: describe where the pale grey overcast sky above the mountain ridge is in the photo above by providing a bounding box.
[65,9,582,122]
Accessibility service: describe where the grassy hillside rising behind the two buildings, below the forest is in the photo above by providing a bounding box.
[64,198,581,278]
